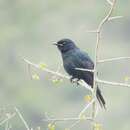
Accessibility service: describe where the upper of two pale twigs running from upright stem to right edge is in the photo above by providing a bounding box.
[98,57,130,63]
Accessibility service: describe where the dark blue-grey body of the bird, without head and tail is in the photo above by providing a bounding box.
[63,49,94,86]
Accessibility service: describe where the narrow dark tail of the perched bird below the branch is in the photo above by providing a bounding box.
[96,87,106,109]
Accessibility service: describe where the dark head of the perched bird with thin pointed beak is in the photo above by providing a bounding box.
[54,39,77,53]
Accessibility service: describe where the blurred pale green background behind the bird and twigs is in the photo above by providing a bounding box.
[0,0,130,130]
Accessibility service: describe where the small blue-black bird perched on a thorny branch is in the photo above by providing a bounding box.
[55,39,106,108]
